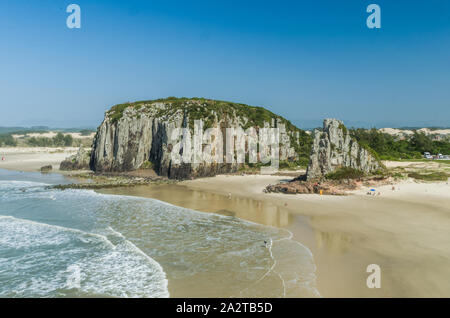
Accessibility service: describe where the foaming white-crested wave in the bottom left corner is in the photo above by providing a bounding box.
[0,216,169,297]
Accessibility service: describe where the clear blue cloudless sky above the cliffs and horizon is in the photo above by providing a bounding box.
[0,0,450,128]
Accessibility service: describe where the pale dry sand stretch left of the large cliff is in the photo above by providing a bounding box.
[0,147,78,172]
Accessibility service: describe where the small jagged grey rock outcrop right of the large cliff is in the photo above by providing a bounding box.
[306,119,383,180]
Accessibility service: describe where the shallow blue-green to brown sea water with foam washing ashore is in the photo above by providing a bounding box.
[0,170,319,297]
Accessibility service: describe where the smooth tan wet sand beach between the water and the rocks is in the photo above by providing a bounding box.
[101,176,450,297]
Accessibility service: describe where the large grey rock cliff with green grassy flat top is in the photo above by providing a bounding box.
[90,98,306,179]
